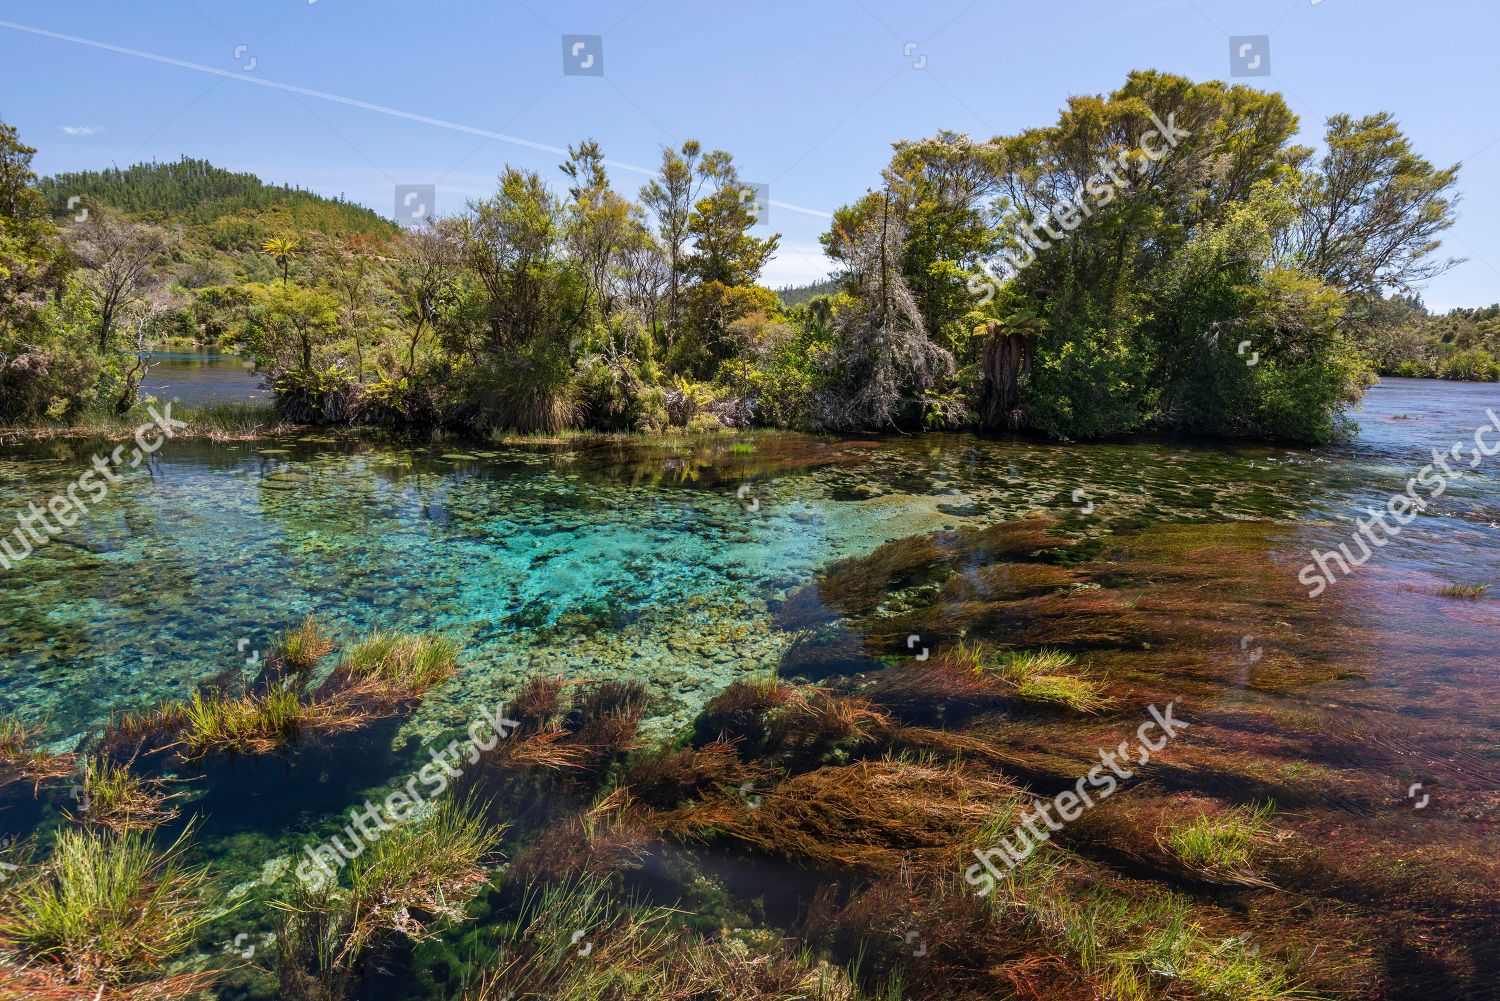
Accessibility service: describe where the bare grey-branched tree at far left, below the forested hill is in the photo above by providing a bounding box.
[66,206,170,351]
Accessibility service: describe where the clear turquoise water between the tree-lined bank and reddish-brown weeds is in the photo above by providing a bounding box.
[0,380,1500,740]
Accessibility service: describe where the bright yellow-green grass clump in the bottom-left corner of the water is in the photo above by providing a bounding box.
[0,830,219,998]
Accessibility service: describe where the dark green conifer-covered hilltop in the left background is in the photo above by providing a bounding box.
[38,156,395,249]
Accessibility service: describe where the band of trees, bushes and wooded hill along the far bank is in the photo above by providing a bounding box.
[0,71,1476,443]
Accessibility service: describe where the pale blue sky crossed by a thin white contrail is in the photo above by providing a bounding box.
[0,0,1500,309]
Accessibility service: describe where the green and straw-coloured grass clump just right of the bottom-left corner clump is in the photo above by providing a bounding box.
[275,800,504,1001]
